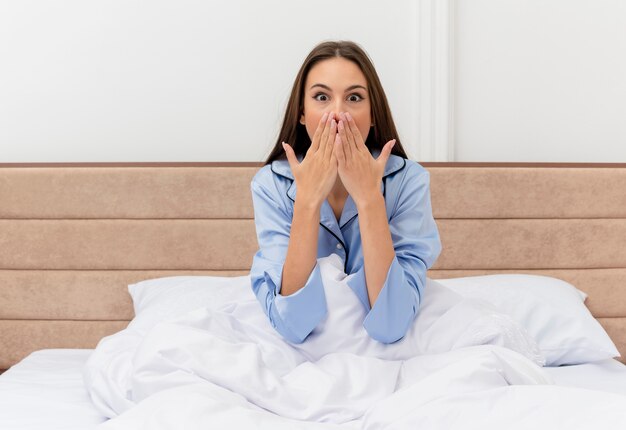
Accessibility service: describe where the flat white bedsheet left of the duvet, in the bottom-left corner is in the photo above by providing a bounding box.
[0,349,106,430]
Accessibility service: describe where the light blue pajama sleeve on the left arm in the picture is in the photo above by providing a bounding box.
[250,173,327,343]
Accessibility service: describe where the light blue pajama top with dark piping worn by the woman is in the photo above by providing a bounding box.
[250,150,441,343]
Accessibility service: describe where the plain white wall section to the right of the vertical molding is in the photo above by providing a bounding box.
[454,0,626,162]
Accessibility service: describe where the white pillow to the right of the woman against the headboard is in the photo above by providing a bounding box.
[437,274,620,366]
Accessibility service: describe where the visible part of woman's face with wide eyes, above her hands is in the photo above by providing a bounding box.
[300,57,372,141]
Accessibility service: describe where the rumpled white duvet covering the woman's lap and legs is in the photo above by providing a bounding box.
[84,254,626,430]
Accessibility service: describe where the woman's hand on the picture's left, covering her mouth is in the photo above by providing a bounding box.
[283,112,337,207]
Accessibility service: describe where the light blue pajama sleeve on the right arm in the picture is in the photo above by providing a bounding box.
[348,165,441,343]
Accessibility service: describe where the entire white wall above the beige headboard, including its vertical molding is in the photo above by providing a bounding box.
[0,0,626,162]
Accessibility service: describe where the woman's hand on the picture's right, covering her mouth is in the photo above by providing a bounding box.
[334,112,396,207]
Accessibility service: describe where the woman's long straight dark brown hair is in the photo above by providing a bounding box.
[265,40,408,164]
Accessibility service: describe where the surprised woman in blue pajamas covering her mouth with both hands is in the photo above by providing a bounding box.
[250,41,441,343]
